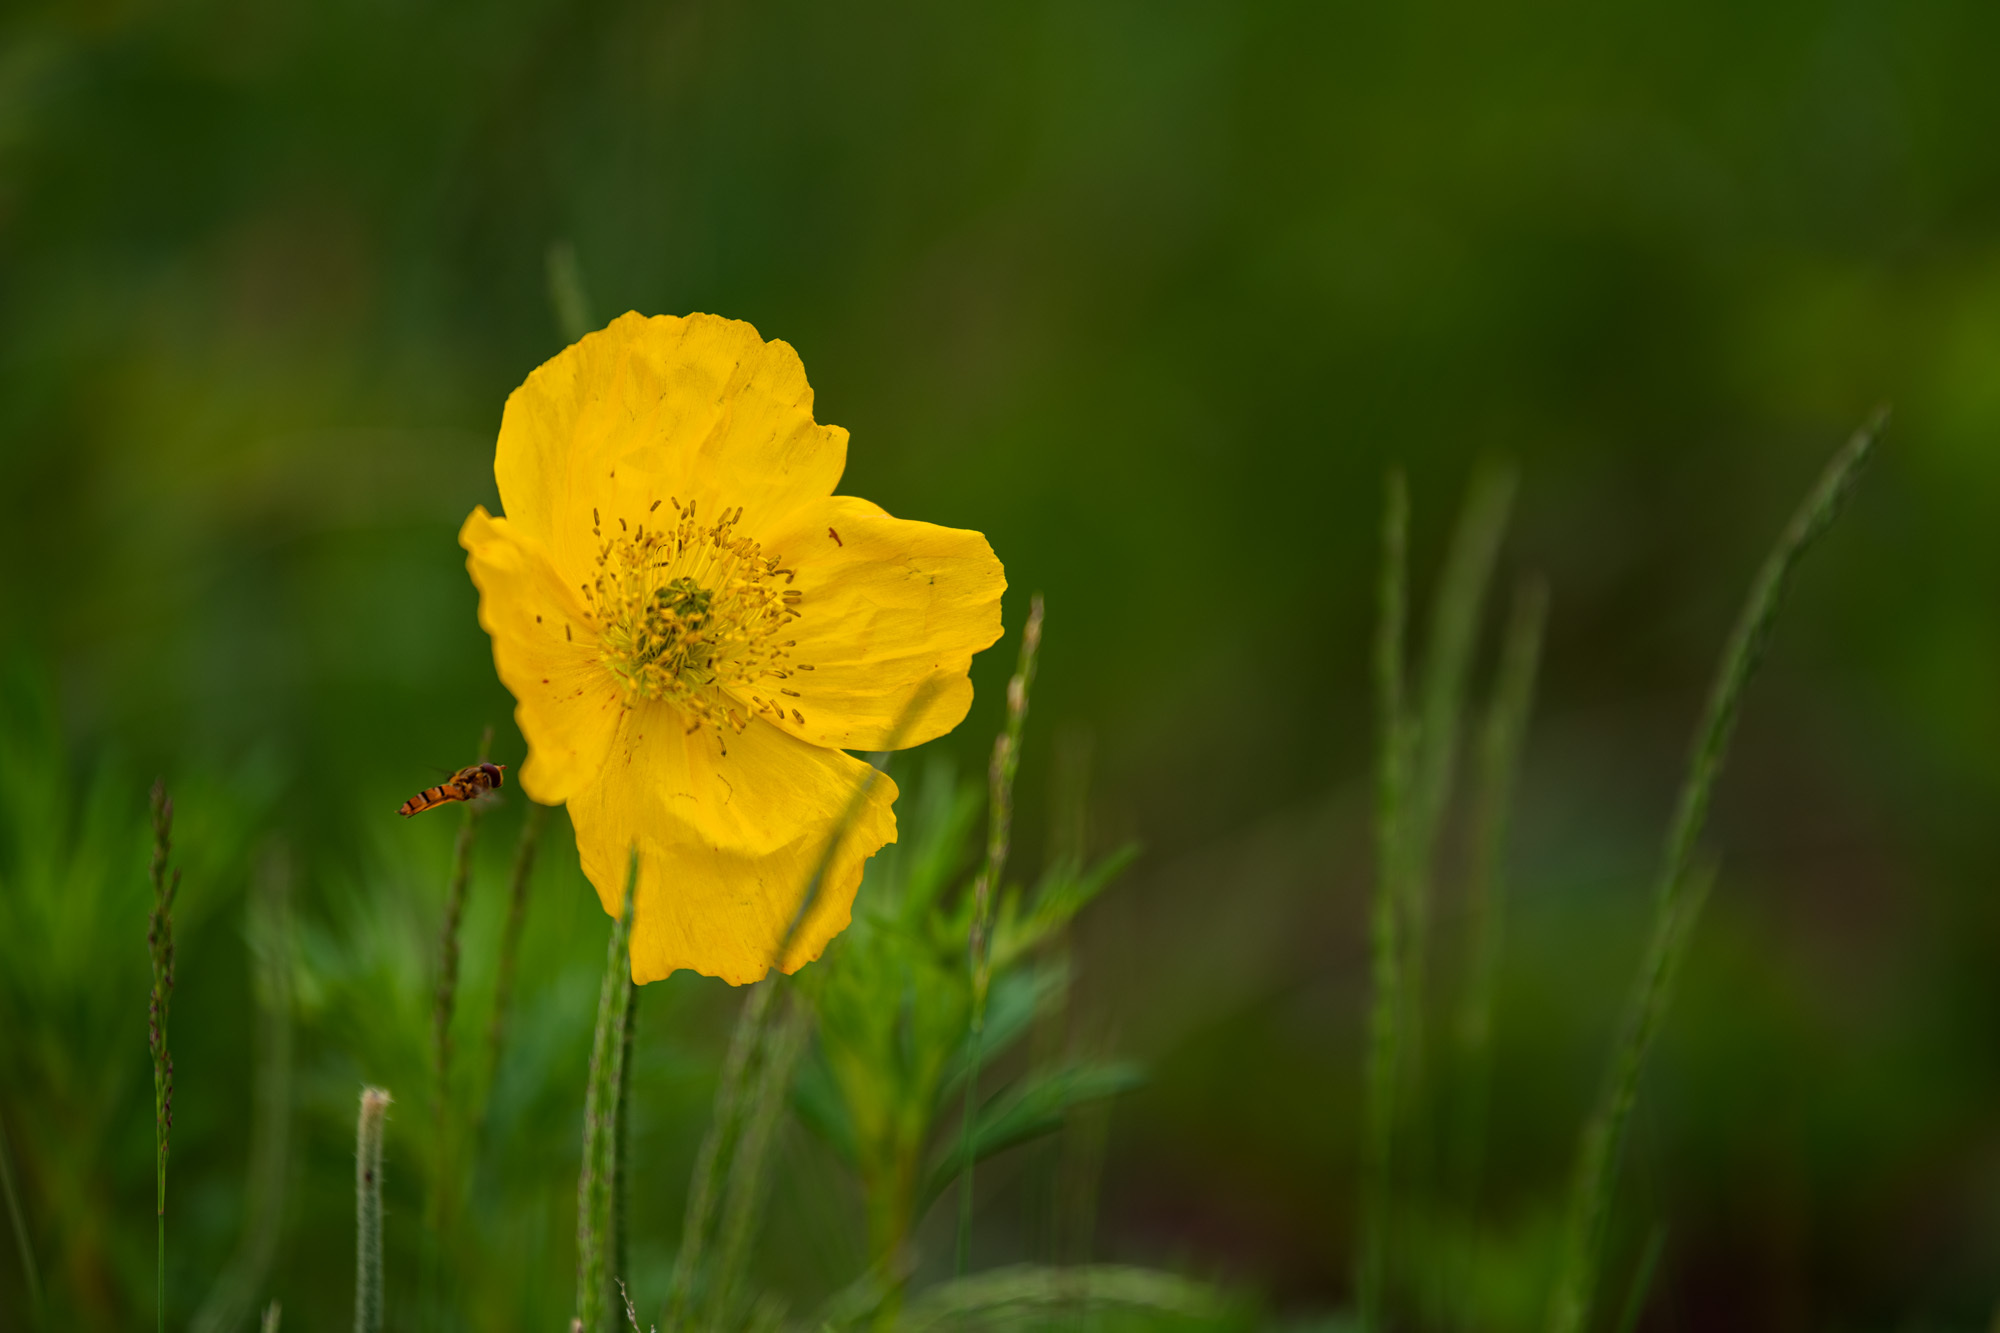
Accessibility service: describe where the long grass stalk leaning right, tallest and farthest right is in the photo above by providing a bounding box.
[1548,412,1886,1333]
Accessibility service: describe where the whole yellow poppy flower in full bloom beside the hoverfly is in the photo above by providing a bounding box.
[458,314,1006,985]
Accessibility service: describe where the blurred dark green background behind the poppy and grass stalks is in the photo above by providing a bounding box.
[0,0,2000,1329]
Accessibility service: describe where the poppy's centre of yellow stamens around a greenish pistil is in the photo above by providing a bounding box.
[584,500,812,735]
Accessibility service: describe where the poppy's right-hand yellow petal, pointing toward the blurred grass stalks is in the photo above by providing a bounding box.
[744,496,1006,751]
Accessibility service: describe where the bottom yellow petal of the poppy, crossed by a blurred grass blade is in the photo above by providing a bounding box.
[570,703,896,985]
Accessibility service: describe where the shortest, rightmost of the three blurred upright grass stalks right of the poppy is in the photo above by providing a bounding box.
[1454,580,1548,1315]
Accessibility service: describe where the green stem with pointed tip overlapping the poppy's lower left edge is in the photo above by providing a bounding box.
[576,847,638,1333]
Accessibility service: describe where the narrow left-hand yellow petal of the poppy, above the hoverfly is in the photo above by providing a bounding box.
[458,506,624,805]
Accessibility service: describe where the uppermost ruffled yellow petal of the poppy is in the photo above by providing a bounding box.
[494,314,848,582]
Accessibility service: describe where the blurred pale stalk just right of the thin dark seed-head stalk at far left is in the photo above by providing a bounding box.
[190,845,292,1333]
